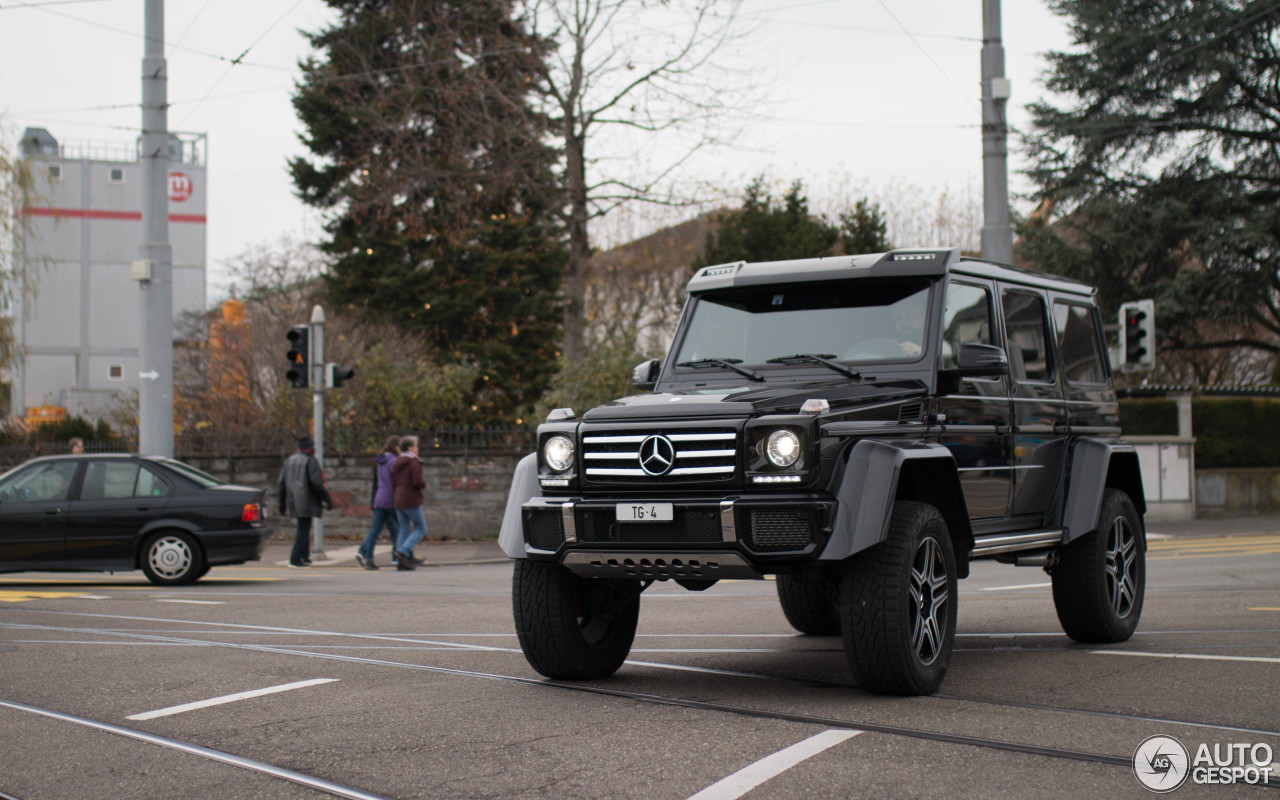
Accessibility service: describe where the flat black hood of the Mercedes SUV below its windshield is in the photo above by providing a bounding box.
[582,380,927,422]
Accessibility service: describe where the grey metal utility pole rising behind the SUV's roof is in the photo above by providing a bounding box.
[982,0,1014,264]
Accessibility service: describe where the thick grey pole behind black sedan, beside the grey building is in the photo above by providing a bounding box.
[133,0,173,457]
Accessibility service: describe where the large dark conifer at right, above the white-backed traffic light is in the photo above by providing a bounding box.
[1019,0,1280,373]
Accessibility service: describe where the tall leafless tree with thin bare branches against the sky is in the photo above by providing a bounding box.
[527,0,751,361]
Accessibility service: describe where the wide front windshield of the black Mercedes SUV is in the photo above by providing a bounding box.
[676,278,929,365]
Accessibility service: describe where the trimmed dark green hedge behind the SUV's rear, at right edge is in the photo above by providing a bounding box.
[1120,397,1280,468]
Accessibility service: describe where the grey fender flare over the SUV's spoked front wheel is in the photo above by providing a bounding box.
[820,439,973,564]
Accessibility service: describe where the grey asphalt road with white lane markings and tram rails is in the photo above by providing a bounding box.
[0,518,1280,800]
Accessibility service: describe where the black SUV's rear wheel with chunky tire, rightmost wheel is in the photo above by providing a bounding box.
[1052,489,1147,644]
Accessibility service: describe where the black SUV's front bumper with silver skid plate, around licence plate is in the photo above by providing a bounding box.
[521,494,836,579]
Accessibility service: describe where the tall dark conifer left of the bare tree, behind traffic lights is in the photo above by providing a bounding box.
[291,0,564,420]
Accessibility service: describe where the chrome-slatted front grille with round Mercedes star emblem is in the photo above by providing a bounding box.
[582,428,737,483]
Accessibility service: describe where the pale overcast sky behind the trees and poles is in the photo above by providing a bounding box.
[0,0,1069,302]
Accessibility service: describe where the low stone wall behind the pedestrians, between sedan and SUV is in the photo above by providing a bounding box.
[184,453,521,539]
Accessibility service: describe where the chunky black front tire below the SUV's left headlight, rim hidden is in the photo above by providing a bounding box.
[512,558,640,681]
